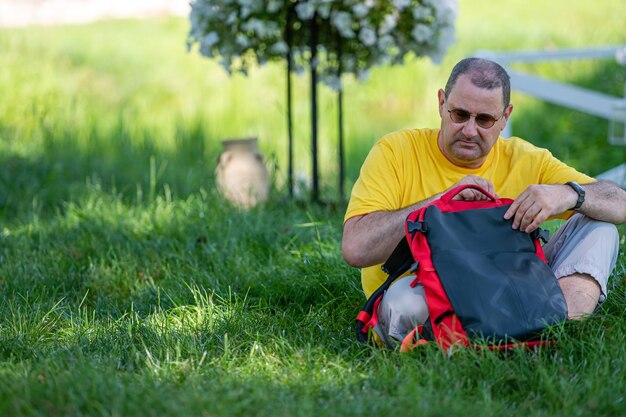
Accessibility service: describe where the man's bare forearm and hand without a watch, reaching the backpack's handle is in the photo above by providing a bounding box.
[341,175,495,268]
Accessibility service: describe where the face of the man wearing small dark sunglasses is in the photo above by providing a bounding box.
[438,75,513,168]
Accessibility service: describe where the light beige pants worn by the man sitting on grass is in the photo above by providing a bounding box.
[374,213,619,347]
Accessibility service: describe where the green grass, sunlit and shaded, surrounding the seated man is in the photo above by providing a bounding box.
[0,0,626,416]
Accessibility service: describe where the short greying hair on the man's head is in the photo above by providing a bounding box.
[444,58,511,109]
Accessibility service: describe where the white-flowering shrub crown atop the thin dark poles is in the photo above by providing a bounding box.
[188,0,457,88]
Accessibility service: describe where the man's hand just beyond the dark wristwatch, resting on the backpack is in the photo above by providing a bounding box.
[504,184,577,233]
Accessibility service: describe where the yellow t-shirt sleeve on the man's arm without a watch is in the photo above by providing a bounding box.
[344,138,400,222]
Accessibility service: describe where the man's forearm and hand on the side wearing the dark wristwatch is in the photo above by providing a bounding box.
[504,181,626,233]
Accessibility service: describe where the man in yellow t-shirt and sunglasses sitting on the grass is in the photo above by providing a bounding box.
[342,58,626,346]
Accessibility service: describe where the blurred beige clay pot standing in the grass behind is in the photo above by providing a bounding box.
[215,138,270,208]
